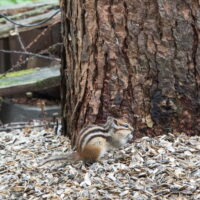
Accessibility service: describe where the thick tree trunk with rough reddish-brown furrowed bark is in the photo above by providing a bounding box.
[61,0,200,141]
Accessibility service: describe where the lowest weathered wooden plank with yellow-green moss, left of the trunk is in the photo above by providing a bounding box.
[0,65,60,96]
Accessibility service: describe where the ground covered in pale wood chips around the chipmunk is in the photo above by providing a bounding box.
[0,121,200,200]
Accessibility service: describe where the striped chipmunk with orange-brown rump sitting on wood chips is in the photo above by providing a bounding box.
[42,117,133,165]
